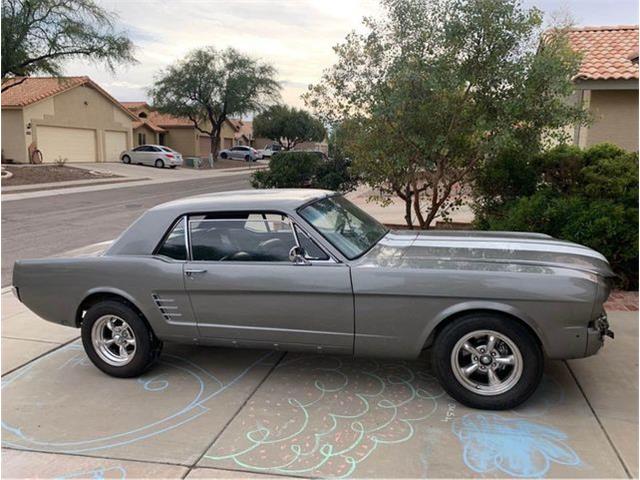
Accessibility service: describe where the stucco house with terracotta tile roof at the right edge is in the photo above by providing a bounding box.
[568,25,639,152]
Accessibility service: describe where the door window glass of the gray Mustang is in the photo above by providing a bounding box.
[189,213,296,262]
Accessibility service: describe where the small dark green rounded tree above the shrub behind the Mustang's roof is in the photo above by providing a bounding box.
[253,105,325,150]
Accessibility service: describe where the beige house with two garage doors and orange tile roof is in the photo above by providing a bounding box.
[2,77,135,163]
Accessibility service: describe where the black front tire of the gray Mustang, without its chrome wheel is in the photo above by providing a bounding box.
[432,314,544,410]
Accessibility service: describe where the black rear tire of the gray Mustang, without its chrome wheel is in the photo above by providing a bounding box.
[81,300,156,378]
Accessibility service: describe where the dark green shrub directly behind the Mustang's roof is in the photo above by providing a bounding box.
[251,151,356,191]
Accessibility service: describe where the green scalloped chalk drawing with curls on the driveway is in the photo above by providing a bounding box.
[204,356,444,478]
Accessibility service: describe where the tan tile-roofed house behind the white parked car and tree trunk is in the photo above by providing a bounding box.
[122,102,250,158]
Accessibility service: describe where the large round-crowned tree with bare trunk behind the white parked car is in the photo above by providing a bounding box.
[149,47,280,159]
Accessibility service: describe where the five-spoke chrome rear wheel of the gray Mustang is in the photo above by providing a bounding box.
[91,315,136,367]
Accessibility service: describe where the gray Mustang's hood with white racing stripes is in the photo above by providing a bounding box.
[360,230,615,277]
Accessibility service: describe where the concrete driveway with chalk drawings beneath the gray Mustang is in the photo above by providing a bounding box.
[2,286,638,478]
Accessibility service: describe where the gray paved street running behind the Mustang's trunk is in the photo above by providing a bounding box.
[2,172,250,287]
